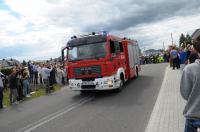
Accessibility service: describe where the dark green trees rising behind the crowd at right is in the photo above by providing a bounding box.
[179,33,192,47]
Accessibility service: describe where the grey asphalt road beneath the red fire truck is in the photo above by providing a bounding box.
[0,64,167,132]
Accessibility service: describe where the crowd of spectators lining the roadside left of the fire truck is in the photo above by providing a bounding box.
[0,61,66,108]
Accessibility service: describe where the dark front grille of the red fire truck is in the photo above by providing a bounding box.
[74,65,101,76]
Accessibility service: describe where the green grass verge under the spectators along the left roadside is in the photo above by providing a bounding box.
[3,84,62,106]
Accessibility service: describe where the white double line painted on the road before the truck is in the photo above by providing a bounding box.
[16,97,94,132]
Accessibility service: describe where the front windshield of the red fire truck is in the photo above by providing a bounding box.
[68,42,106,61]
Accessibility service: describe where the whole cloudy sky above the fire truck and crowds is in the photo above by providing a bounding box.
[0,0,200,60]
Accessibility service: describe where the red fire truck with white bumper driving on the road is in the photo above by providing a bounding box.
[62,32,140,92]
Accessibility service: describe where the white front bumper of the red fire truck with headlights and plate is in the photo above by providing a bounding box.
[69,75,120,91]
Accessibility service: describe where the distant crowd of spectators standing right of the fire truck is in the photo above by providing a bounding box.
[140,44,198,70]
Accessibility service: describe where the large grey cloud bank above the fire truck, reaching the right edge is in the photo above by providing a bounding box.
[43,0,200,32]
